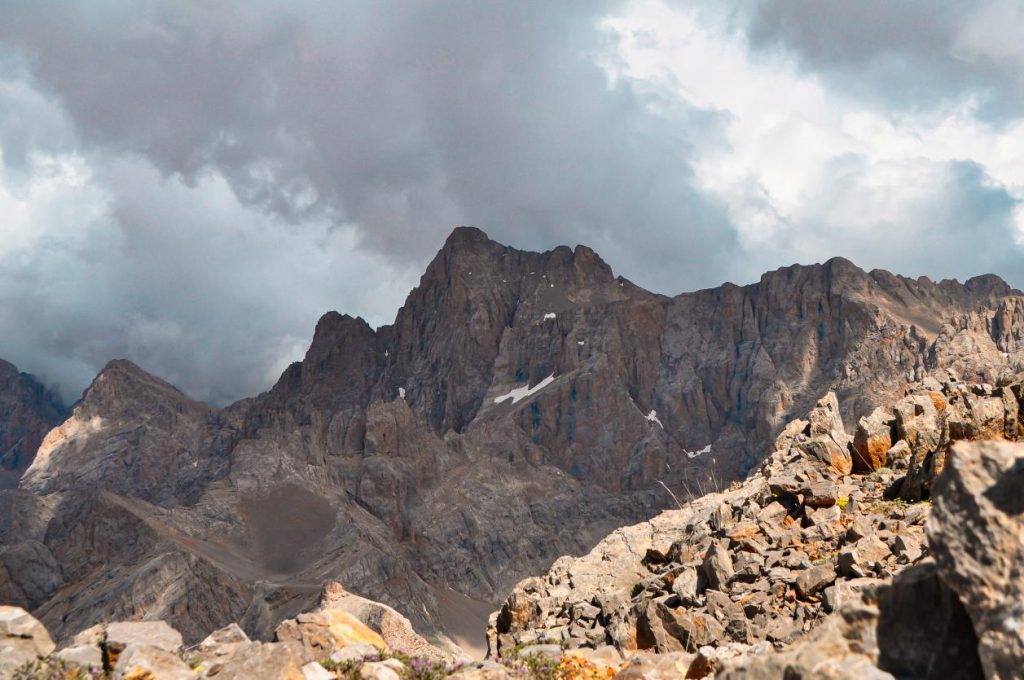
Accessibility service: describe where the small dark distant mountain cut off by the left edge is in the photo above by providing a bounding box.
[0,359,68,488]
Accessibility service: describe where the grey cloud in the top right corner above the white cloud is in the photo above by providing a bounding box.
[746,0,1024,122]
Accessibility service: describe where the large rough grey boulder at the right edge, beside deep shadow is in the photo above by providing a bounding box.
[926,441,1024,678]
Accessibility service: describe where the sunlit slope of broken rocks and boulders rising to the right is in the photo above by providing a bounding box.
[488,375,1024,678]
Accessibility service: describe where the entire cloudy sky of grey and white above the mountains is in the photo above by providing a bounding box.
[0,0,1024,403]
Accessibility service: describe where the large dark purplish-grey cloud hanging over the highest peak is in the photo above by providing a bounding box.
[0,1,728,270]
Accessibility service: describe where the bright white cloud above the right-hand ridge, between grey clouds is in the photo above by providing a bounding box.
[603,0,1024,270]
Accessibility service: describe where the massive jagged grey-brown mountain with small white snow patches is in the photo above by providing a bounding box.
[0,227,1024,655]
